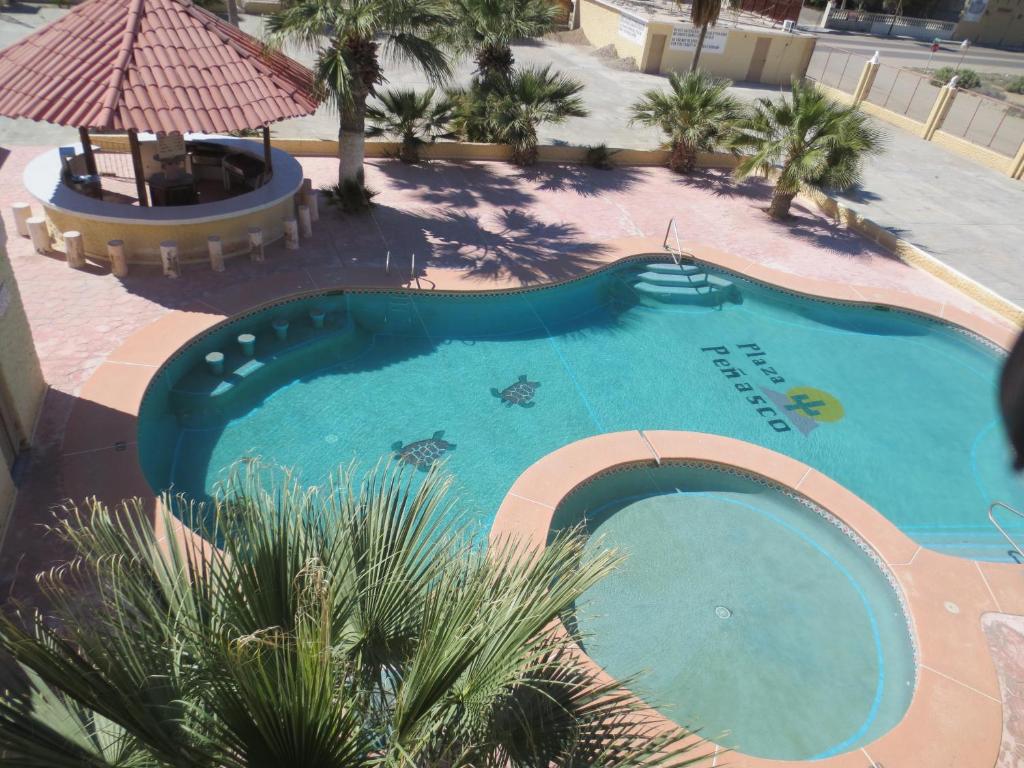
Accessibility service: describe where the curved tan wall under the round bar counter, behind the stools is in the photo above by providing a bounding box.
[44,198,295,264]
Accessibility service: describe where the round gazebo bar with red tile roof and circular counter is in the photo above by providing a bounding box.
[0,0,316,260]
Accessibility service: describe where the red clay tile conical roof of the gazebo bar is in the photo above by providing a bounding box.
[0,0,316,133]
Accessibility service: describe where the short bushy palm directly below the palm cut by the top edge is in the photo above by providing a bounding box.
[454,65,590,166]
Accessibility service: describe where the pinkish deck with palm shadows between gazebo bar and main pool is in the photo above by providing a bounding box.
[0,147,1024,768]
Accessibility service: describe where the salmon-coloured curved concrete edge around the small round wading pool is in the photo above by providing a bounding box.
[489,430,1007,768]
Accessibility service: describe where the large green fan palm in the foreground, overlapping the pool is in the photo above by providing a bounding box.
[0,465,700,768]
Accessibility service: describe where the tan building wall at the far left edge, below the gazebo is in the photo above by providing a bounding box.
[0,222,45,444]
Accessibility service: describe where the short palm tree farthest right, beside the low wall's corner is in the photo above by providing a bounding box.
[729,80,883,218]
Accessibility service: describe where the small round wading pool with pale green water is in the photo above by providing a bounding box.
[552,464,915,760]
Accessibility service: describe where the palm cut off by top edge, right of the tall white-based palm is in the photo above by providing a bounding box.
[443,0,558,82]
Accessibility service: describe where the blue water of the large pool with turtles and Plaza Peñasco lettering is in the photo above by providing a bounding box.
[139,259,1024,559]
